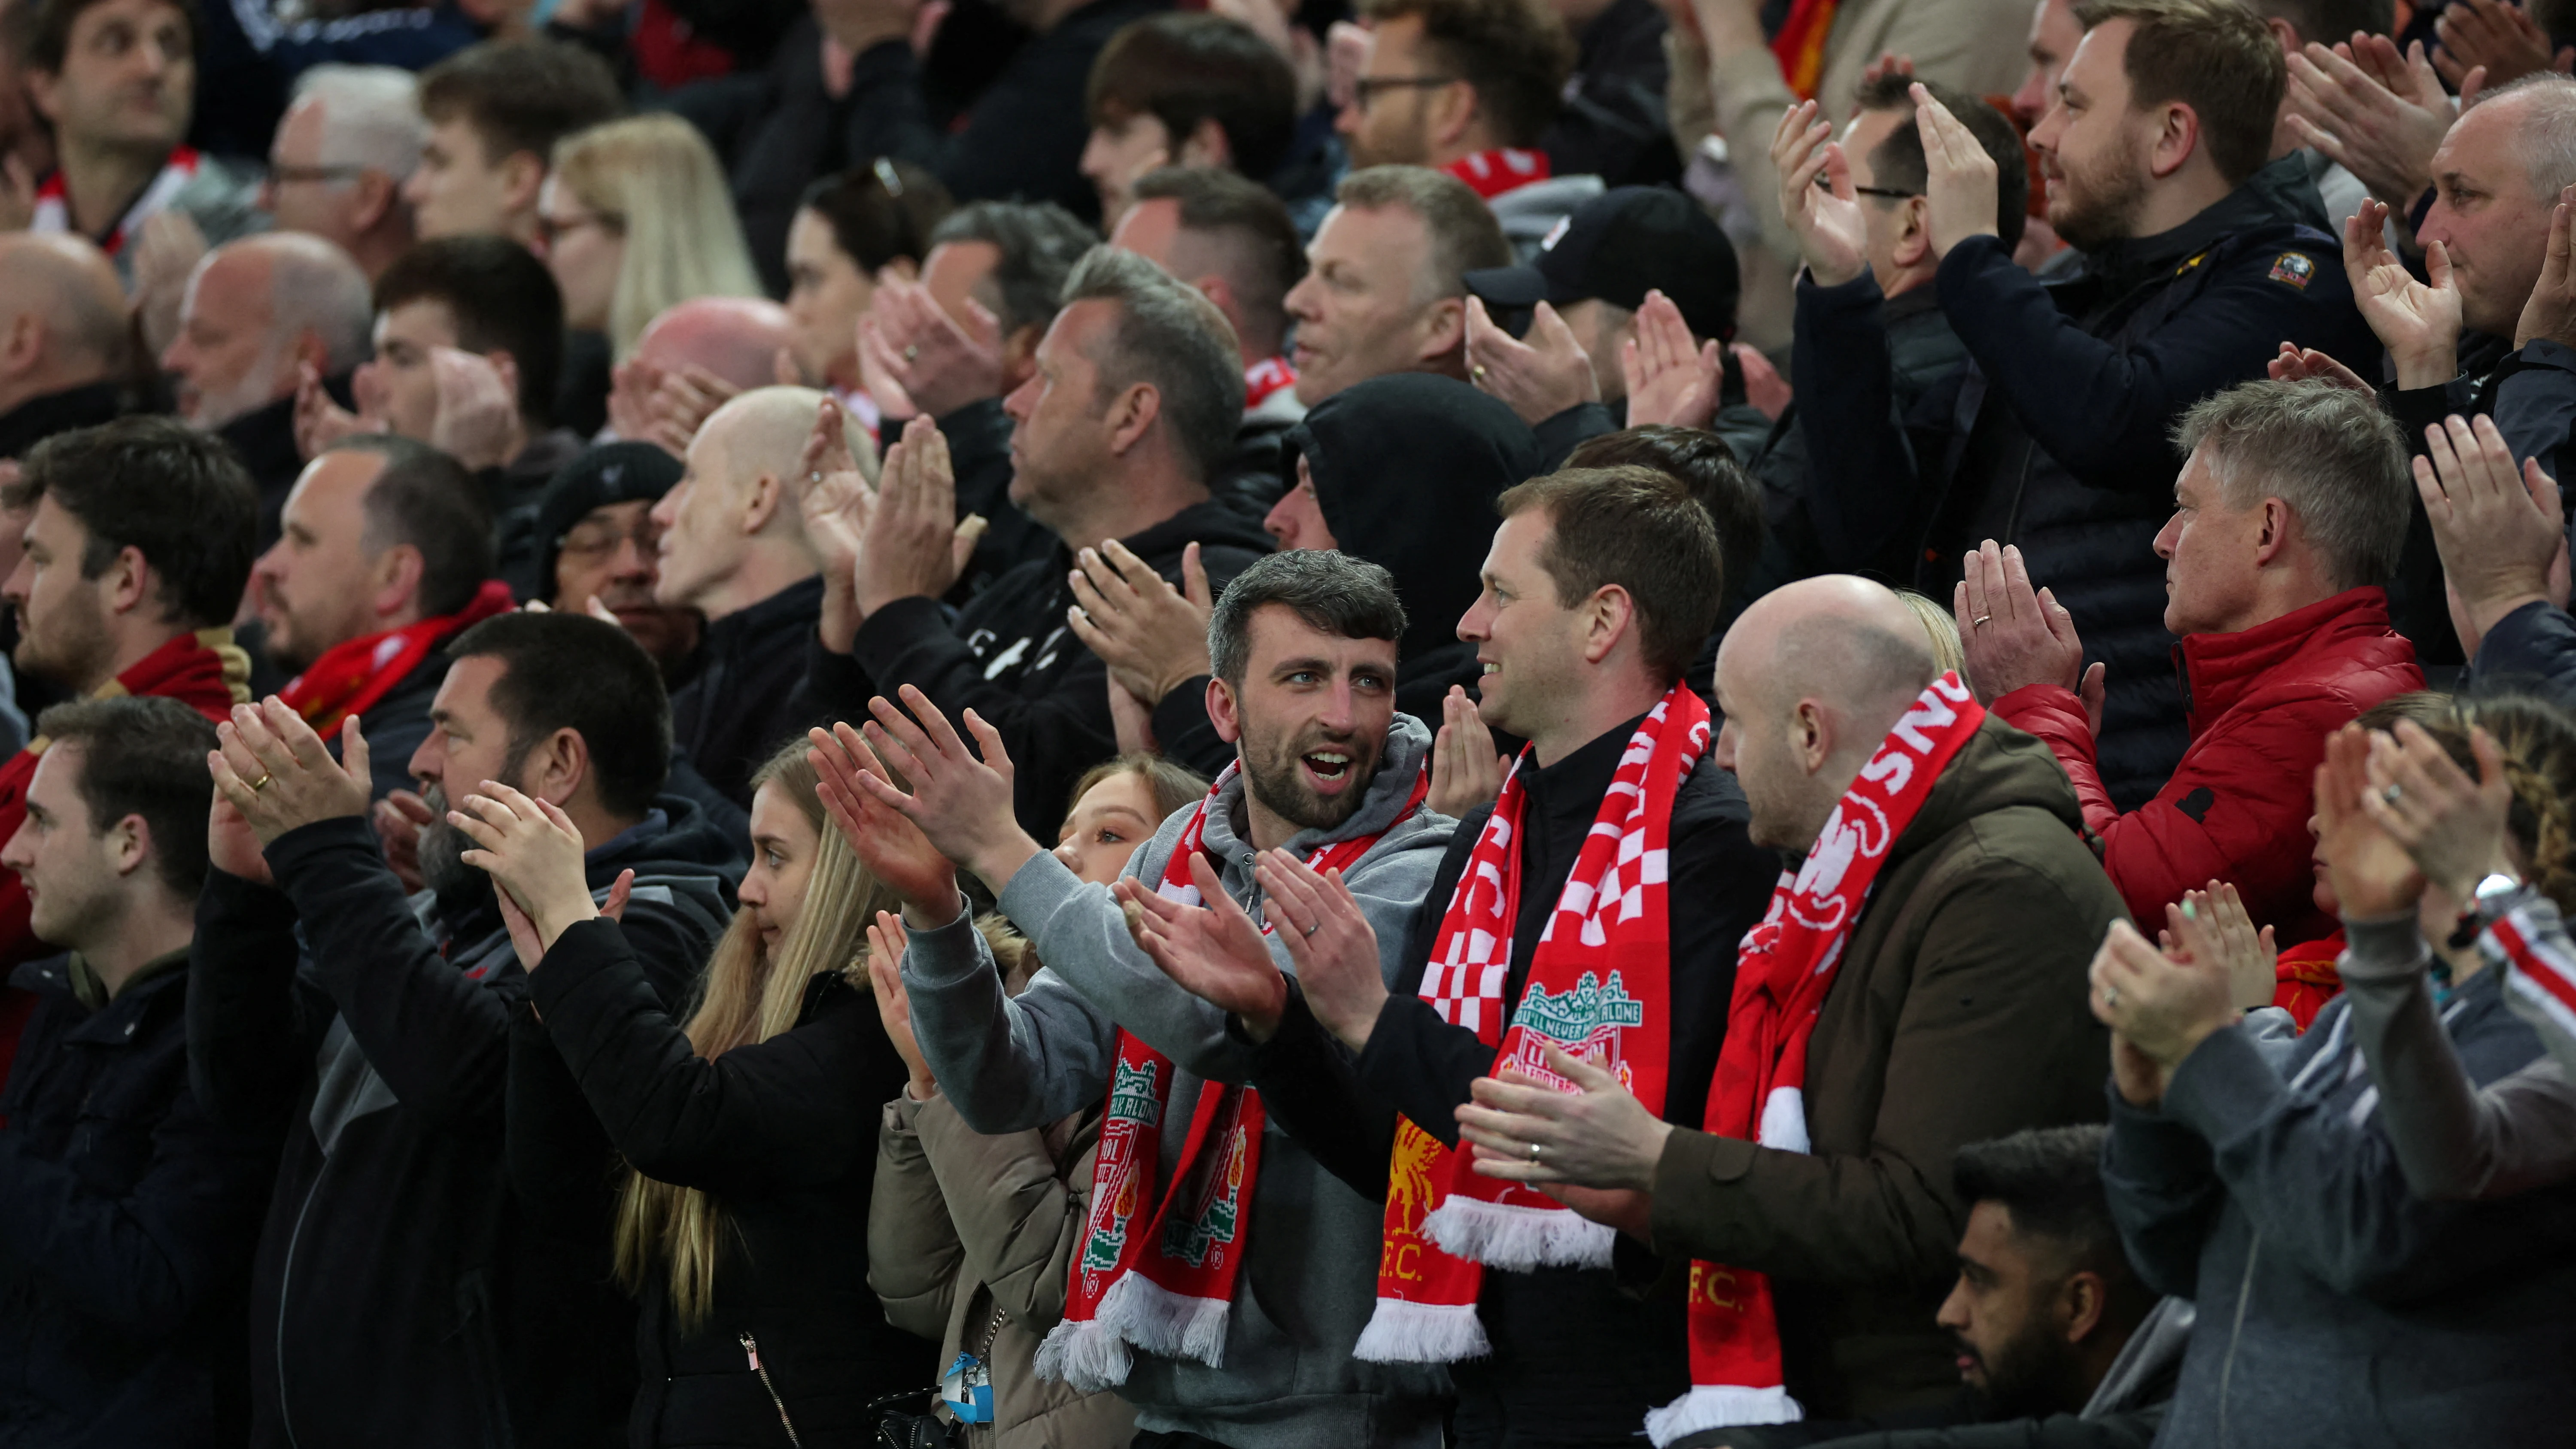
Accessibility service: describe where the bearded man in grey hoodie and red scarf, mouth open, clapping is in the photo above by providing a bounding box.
[819,552,1450,1449]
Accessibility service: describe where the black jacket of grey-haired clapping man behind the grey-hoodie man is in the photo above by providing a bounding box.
[804,500,1270,841]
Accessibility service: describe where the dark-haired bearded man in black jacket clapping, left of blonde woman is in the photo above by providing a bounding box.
[188,614,739,1449]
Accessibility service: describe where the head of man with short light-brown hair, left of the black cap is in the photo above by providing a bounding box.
[1288,165,1515,407]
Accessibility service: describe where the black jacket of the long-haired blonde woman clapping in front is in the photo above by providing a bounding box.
[510,920,940,1449]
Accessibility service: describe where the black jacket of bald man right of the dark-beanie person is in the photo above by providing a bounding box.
[670,575,822,810]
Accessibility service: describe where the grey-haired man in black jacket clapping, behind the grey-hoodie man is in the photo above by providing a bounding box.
[806,248,1270,838]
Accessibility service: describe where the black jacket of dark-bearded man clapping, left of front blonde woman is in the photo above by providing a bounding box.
[188,797,737,1449]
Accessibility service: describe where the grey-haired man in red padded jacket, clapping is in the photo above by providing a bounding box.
[1958,371,2421,946]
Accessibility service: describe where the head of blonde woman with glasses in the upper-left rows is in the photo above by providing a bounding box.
[536,116,762,358]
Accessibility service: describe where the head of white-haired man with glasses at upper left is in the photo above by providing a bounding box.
[260,64,430,281]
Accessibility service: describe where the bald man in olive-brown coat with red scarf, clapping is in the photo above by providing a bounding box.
[1458,575,2123,1423]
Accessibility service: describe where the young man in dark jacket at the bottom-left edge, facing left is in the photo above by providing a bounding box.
[0,696,283,1446]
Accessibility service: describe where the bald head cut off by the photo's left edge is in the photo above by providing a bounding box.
[0,232,131,459]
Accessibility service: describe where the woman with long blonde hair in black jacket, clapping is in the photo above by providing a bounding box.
[479,740,933,1449]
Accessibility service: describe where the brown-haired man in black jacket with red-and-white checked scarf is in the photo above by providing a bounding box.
[1167,467,1777,1446]
